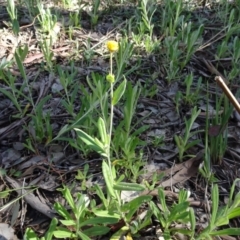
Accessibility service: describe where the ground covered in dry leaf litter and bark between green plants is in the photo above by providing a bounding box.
[0,1,240,239]
